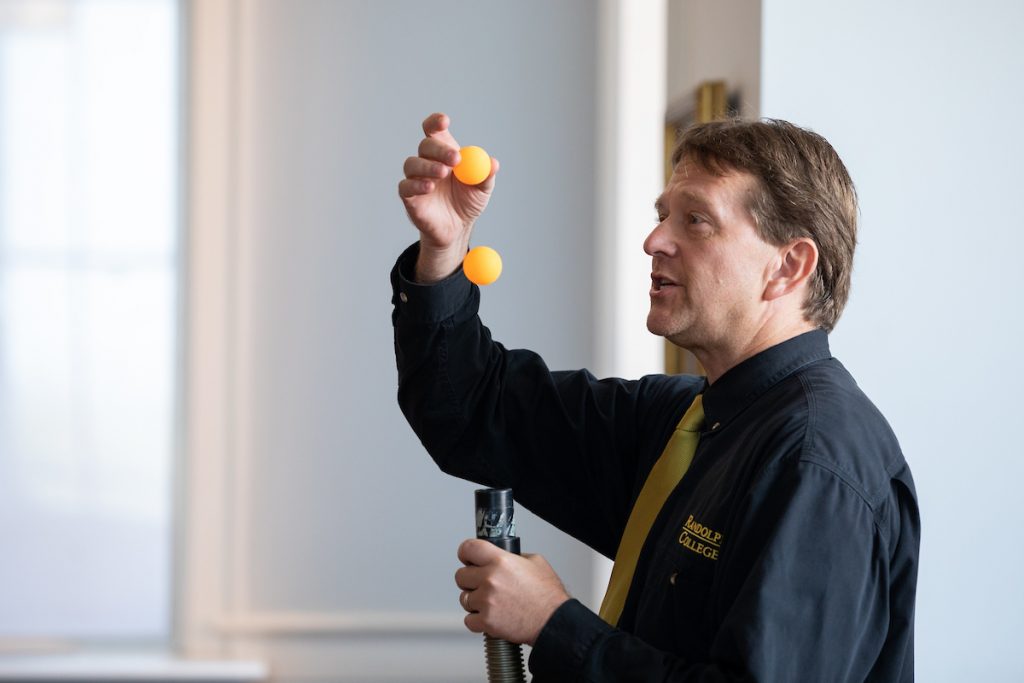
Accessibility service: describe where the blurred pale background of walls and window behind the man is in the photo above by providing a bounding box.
[0,0,1024,683]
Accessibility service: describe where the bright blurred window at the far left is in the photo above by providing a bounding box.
[0,0,180,642]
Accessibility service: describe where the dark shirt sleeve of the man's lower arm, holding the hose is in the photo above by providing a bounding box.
[529,459,889,683]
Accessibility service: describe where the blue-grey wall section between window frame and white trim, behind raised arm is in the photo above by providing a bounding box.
[231,1,594,609]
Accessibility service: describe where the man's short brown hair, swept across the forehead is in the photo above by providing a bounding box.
[672,119,857,332]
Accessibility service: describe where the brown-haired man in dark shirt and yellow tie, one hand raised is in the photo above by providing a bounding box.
[391,114,920,681]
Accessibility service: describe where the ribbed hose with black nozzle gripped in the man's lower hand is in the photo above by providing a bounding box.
[475,488,526,683]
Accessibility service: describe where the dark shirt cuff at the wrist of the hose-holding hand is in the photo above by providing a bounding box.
[529,599,613,681]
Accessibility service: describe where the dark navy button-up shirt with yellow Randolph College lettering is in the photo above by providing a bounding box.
[391,246,920,682]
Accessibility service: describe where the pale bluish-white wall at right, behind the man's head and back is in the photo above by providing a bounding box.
[761,0,1024,683]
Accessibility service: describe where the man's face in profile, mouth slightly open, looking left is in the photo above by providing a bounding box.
[644,159,778,354]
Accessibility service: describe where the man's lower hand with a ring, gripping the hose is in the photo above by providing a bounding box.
[455,539,569,645]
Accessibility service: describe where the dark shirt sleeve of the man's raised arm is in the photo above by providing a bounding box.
[391,245,697,557]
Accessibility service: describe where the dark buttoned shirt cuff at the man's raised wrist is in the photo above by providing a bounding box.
[391,242,480,325]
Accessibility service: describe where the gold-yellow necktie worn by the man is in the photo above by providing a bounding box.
[600,394,703,626]
